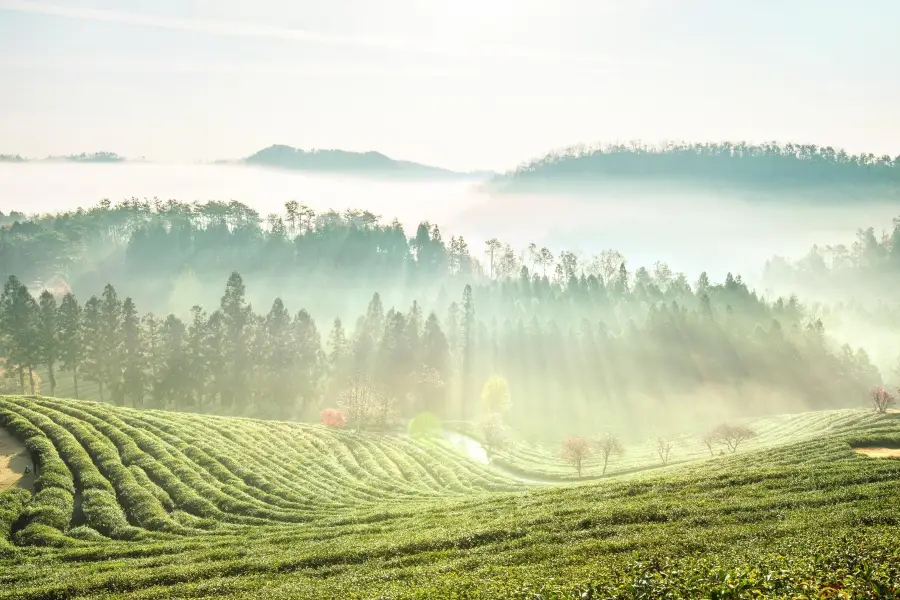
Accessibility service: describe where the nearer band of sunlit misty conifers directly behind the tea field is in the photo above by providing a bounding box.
[0,255,881,437]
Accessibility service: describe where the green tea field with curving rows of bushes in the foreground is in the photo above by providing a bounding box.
[0,397,900,599]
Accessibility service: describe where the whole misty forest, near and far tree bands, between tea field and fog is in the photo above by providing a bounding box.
[0,200,884,435]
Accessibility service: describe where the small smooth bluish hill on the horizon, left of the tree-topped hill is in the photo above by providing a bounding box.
[240,144,494,178]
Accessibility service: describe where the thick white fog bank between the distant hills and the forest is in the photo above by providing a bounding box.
[0,163,898,292]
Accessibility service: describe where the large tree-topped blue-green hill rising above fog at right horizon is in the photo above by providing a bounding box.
[496,142,900,190]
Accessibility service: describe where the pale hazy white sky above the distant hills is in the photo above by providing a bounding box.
[0,0,900,169]
